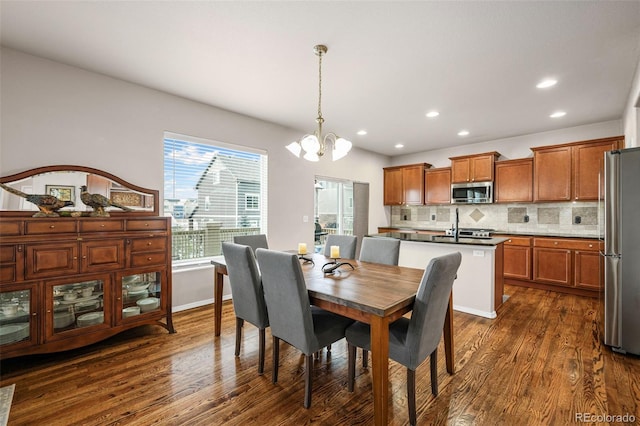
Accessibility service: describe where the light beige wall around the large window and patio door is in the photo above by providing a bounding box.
[0,48,389,253]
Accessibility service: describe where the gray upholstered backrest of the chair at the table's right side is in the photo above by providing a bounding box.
[406,252,462,370]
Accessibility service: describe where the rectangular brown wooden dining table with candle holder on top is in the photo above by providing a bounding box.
[211,253,454,425]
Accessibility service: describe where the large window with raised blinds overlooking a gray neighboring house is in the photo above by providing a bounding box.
[164,133,267,263]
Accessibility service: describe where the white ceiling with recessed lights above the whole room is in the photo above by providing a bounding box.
[0,0,640,155]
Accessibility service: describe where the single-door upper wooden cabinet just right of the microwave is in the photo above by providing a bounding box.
[495,158,533,203]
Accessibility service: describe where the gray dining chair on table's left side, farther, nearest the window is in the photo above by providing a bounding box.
[222,242,269,374]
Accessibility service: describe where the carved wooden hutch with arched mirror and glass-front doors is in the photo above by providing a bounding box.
[0,166,175,358]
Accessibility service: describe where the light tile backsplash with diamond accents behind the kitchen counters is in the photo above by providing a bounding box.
[390,201,604,237]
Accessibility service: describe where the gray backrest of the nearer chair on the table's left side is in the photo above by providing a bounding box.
[256,249,318,354]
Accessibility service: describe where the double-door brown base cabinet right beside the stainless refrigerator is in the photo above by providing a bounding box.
[533,238,604,291]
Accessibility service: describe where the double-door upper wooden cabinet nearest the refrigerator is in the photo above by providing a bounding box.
[532,136,624,201]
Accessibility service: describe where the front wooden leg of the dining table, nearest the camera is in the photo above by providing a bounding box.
[370,316,389,425]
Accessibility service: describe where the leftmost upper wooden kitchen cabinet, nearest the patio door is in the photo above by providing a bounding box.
[383,163,431,206]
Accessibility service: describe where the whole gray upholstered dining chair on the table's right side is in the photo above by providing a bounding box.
[346,252,462,425]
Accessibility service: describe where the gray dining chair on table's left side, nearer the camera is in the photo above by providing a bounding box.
[256,249,353,408]
